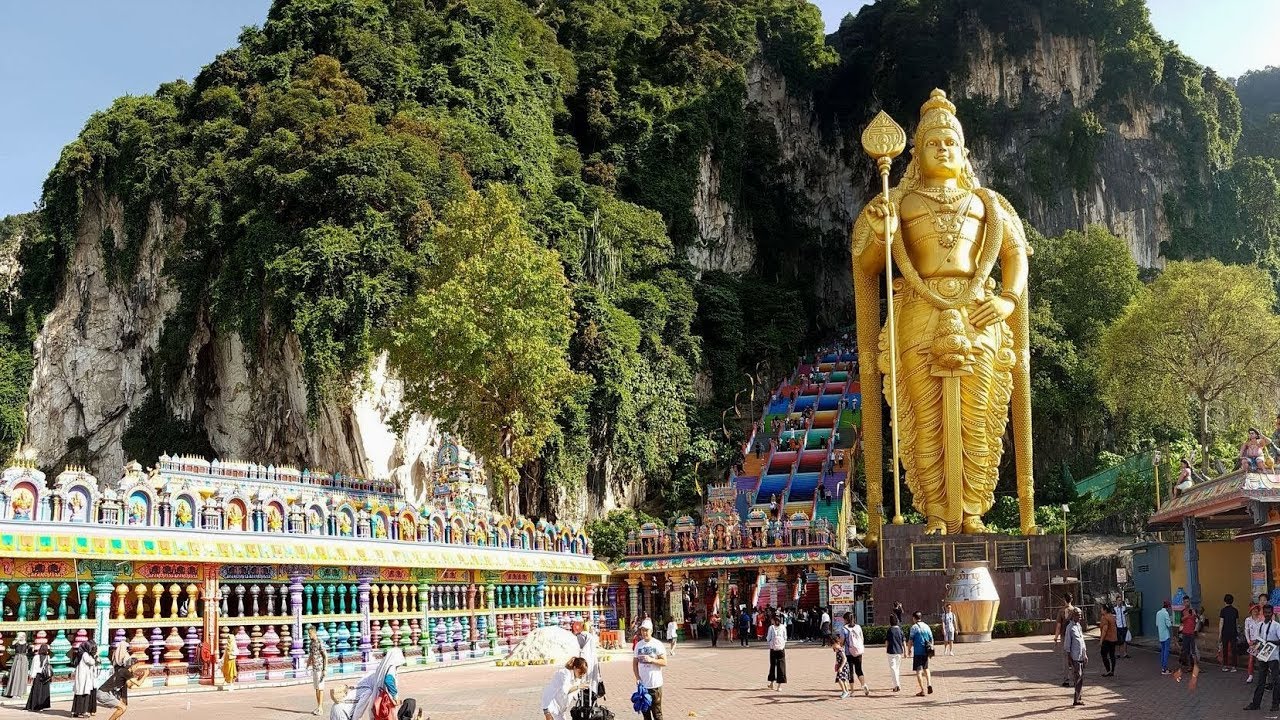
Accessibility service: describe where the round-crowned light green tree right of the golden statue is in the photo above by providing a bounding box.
[1101,260,1280,468]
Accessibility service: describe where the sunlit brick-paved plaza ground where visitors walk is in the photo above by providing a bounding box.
[0,638,1277,720]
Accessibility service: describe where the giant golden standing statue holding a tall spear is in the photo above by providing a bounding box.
[852,90,1037,542]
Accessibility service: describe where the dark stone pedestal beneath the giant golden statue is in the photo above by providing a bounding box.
[869,524,1062,622]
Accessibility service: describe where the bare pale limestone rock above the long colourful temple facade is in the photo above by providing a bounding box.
[26,184,468,500]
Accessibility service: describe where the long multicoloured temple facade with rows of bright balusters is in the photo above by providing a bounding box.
[0,442,609,693]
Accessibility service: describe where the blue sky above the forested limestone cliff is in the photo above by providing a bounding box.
[0,0,1280,215]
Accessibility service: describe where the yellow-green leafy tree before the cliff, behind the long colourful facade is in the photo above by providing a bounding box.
[385,186,585,514]
